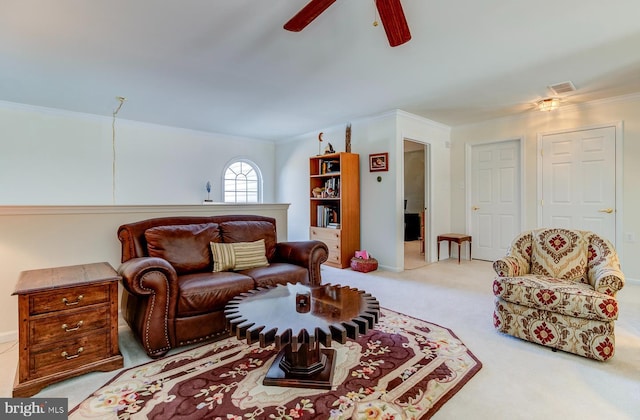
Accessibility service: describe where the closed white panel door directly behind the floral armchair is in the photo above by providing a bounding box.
[541,127,616,244]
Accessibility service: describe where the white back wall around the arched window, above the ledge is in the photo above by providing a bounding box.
[0,102,275,205]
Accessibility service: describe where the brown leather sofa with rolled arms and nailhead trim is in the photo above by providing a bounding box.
[118,215,328,357]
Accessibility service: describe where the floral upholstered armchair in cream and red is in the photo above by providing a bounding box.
[493,228,624,361]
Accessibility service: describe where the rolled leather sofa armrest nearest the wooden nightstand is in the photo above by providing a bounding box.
[118,257,178,357]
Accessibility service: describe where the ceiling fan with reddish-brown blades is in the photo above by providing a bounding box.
[284,0,411,47]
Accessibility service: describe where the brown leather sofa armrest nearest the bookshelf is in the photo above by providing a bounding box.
[274,241,329,286]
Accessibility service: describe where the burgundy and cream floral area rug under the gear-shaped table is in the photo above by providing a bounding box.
[69,309,482,420]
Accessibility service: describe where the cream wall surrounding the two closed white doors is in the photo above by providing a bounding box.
[450,95,640,280]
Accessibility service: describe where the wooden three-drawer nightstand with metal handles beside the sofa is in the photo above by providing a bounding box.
[13,262,123,397]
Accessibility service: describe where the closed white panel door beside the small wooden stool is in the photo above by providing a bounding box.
[468,140,521,261]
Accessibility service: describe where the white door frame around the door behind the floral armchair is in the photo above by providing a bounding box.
[536,121,624,255]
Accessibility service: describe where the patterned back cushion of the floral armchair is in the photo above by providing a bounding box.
[531,229,589,283]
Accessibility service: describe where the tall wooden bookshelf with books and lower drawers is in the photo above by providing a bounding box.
[309,153,360,268]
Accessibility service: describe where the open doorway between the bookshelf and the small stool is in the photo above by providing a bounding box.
[403,139,429,270]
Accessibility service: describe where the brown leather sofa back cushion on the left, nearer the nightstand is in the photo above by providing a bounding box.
[144,223,221,274]
